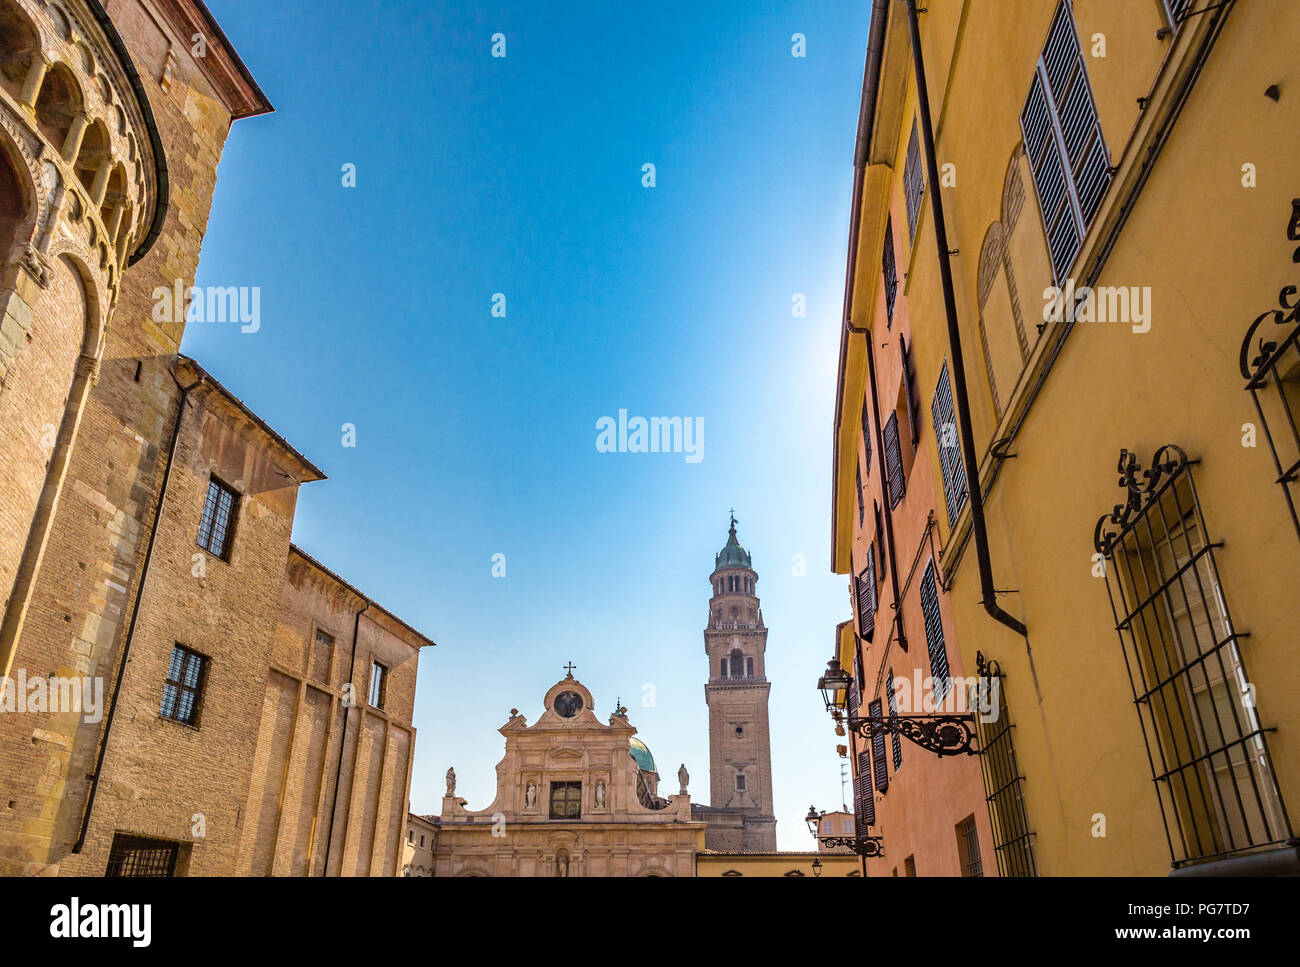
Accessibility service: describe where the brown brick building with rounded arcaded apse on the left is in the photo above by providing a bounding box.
[0,0,432,875]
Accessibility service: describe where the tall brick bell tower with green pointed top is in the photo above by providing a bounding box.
[705,511,776,853]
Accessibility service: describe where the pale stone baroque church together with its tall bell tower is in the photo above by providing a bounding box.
[433,517,785,876]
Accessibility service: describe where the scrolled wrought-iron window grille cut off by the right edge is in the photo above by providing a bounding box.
[1239,257,1300,548]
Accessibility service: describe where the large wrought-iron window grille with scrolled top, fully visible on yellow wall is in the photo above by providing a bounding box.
[1095,446,1292,868]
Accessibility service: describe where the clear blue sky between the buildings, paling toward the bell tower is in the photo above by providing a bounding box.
[183,0,868,849]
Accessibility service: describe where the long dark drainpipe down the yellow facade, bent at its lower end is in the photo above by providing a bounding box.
[904,0,1028,637]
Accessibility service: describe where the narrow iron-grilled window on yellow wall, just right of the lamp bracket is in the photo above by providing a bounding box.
[970,652,1039,876]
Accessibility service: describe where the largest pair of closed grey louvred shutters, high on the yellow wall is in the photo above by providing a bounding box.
[1021,0,1112,285]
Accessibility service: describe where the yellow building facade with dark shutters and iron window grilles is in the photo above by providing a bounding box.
[832,0,1300,875]
